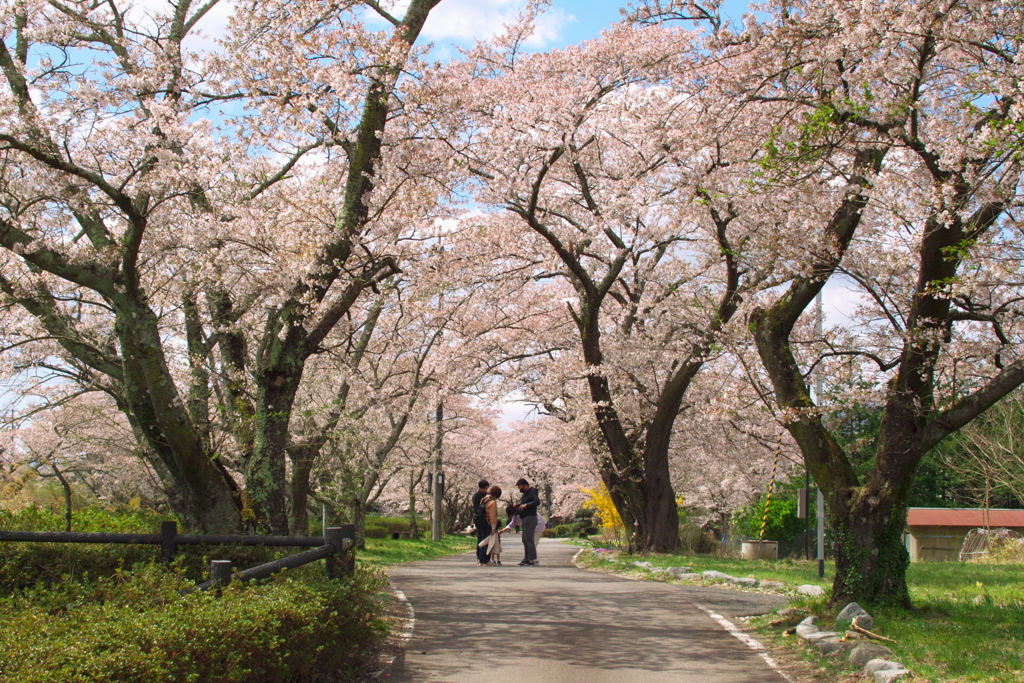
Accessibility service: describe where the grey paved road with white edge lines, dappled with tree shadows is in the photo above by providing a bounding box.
[388,537,784,683]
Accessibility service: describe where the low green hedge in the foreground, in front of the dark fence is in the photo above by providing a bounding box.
[0,562,385,683]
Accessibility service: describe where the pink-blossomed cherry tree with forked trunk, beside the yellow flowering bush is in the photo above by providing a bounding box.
[452,21,763,551]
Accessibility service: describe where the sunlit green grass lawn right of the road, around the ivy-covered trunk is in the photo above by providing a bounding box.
[580,553,1024,683]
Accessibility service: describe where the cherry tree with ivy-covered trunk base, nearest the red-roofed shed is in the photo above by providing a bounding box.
[646,1,1024,604]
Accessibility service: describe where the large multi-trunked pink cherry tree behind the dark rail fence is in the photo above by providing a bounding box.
[0,0,448,531]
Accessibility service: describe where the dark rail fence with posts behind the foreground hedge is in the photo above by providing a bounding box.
[0,521,355,590]
